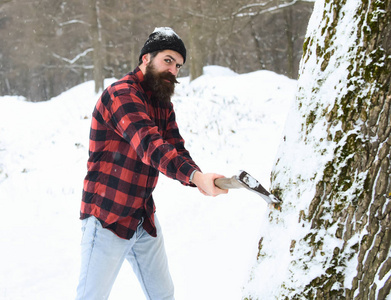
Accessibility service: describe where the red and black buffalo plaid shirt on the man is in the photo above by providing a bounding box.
[80,67,199,239]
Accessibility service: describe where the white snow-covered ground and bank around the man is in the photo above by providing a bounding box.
[0,67,296,300]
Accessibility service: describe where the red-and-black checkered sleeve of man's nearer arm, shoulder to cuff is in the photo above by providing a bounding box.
[107,86,198,184]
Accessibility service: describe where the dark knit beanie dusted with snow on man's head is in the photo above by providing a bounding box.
[139,27,186,63]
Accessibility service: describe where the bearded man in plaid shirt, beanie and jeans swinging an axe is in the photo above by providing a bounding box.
[77,27,228,300]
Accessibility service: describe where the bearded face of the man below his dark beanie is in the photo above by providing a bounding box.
[144,50,183,102]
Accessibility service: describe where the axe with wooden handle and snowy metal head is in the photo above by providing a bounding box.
[215,171,282,206]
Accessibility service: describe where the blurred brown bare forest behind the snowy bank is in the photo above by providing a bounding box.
[0,0,313,101]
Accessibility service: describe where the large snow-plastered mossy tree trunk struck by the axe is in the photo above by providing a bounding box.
[244,0,391,299]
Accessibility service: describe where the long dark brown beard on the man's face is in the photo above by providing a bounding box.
[143,61,178,103]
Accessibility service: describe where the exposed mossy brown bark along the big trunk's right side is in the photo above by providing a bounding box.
[291,0,391,299]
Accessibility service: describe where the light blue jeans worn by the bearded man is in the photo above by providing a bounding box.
[76,215,174,300]
